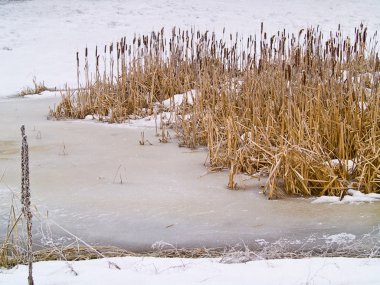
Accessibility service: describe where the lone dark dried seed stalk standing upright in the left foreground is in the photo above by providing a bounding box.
[21,125,34,285]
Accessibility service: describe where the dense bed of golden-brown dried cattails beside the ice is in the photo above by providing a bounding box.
[51,25,380,198]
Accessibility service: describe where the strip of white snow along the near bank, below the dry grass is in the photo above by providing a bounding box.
[0,257,380,285]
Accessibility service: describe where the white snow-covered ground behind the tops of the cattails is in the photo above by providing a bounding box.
[0,0,380,96]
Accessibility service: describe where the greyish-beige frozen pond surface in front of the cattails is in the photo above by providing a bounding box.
[0,97,380,249]
